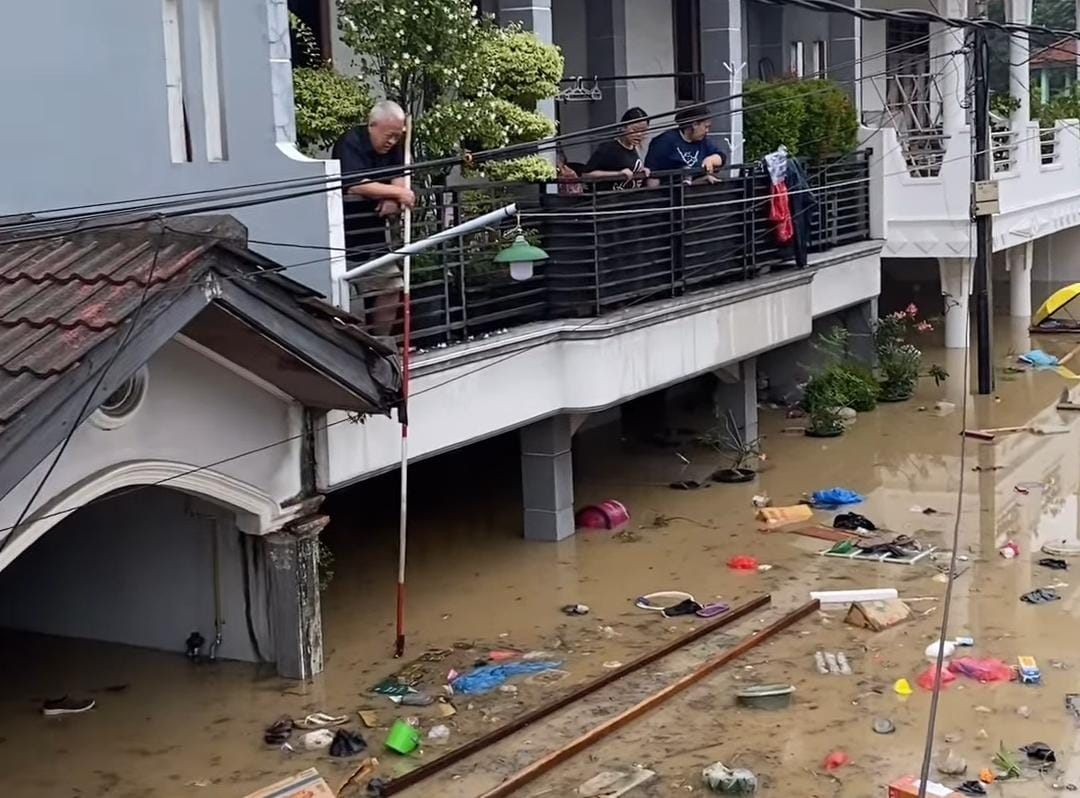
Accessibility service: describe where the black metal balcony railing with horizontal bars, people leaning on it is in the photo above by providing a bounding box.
[346,152,869,347]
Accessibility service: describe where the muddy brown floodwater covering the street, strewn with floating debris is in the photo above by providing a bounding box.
[6,327,1080,798]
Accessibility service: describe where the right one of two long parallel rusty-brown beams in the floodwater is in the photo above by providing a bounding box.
[480,600,820,798]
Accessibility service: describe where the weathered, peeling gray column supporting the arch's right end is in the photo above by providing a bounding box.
[261,515,329,679]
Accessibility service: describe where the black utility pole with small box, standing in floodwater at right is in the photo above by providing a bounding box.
[971,7,999,394]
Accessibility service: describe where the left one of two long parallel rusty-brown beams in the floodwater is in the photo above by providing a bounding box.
[378,594,772,796]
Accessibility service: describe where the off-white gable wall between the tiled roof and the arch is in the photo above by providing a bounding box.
[0,341,302,570]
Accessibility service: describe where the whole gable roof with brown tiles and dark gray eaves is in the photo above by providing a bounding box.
[0,217,401,503]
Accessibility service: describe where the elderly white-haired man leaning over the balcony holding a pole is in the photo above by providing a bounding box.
[334,99,416,336]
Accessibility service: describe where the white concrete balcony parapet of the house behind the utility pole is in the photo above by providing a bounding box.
[860,120,1080,258]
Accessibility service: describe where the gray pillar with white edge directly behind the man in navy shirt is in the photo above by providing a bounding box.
[701,2,746,163]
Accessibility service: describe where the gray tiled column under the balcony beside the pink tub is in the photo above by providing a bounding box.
[521,414,573,541]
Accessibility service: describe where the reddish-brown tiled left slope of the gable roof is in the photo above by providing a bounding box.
[0,230,215,425]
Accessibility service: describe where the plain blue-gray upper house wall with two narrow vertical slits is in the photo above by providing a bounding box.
[0,0,343,295]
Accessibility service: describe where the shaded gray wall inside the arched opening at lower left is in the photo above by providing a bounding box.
[0,488,272,661]
